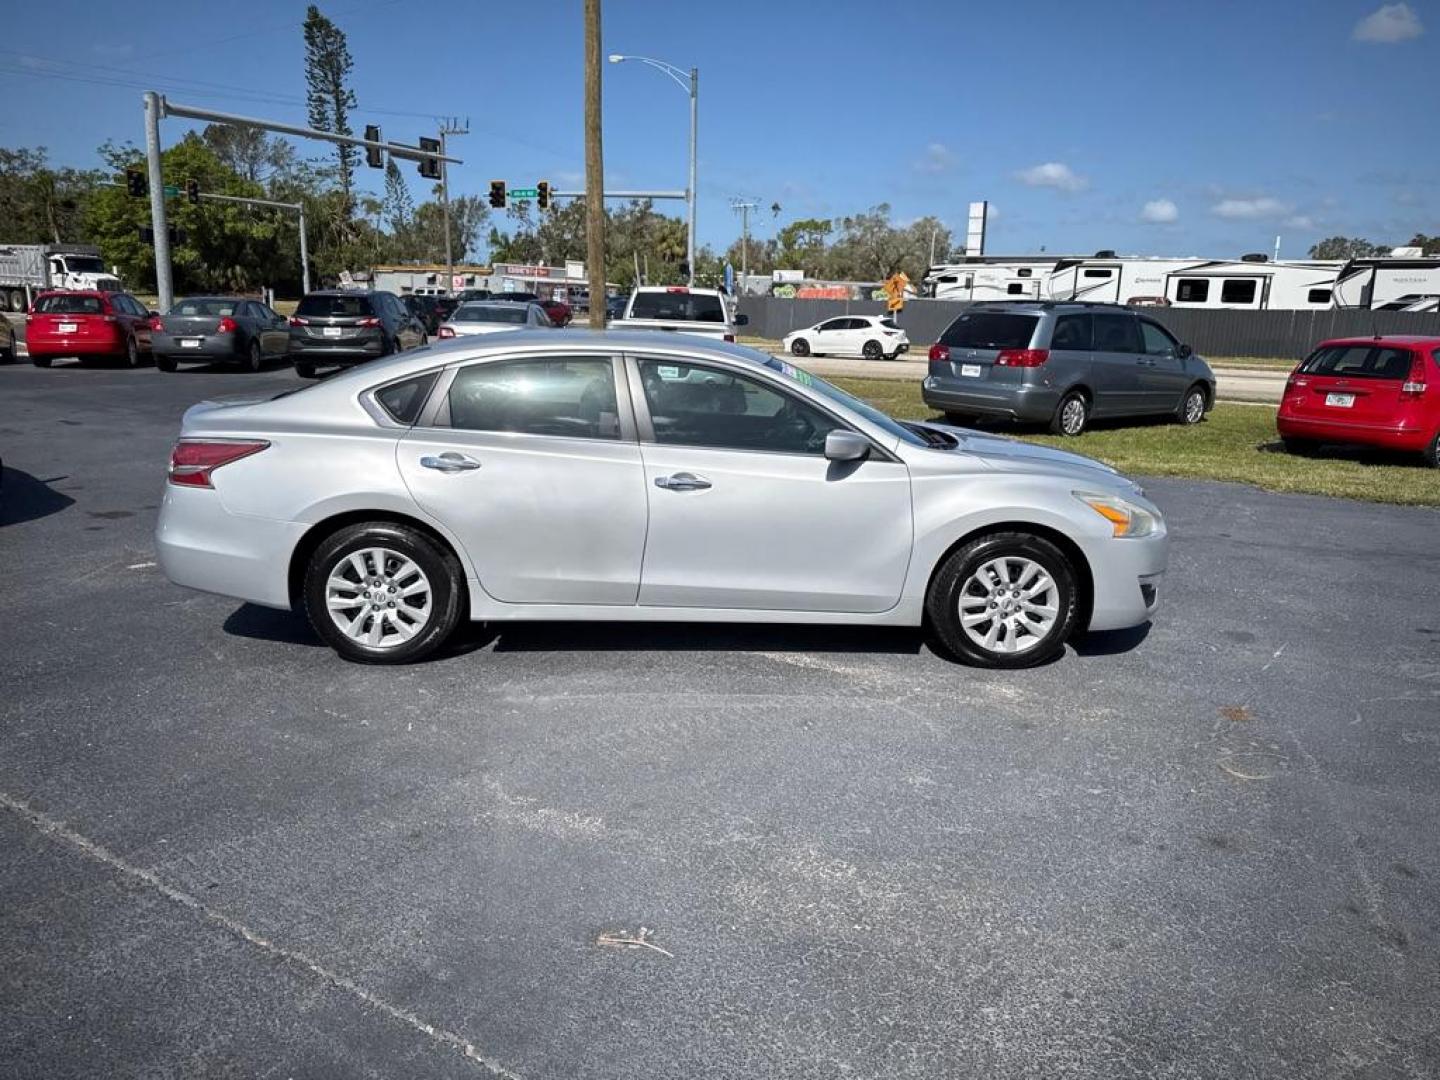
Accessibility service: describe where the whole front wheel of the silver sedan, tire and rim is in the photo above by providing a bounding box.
[924,533,1079,668]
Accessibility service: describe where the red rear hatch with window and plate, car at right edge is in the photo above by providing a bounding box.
[1286,346,1414,426]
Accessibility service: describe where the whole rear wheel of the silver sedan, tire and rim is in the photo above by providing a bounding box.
[305,521,465,664]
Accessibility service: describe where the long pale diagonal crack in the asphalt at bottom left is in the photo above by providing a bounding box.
[0,791,521,1080]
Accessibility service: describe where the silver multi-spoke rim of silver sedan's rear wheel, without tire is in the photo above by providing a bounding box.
[325,547,435,649]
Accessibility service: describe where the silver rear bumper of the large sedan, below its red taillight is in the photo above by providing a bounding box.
[156,484,305,609]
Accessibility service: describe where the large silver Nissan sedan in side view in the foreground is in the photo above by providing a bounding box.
[157,330,1168,668]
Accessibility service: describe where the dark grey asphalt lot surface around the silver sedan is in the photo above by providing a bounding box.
[8,364,1440,1080]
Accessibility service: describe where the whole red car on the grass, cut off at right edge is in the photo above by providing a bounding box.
[1276,336,1440,465]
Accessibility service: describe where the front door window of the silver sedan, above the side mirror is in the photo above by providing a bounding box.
[639,360,844,455]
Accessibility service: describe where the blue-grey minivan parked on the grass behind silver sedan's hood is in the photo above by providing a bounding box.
[922,301,1215,435]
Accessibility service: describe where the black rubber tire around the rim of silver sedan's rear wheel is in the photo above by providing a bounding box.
[304,521,465,664]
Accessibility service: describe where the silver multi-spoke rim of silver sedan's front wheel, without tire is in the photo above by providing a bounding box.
[958,556,1060,655]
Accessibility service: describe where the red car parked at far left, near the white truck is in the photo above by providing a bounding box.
[24,291,150,367]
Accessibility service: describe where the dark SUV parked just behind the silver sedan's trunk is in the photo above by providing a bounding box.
[289,289,429,379]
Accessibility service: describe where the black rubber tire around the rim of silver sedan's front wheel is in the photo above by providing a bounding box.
[924,533,1079,668]
